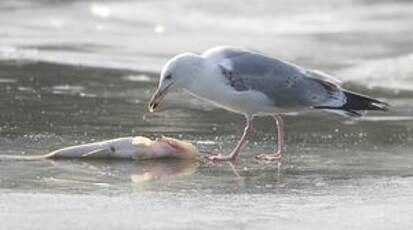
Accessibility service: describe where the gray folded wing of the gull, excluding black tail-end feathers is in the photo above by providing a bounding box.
[214,49,345,108]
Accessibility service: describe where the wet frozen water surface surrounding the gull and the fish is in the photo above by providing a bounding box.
[0,0,413,230]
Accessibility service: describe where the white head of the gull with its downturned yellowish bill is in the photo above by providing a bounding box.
[148,53,202,112]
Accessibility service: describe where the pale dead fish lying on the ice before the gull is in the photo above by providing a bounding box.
[1,136,198,160]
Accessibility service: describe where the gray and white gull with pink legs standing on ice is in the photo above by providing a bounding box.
[148,47,388,162]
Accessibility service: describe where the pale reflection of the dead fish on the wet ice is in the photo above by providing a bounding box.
[43,160,198,189]
